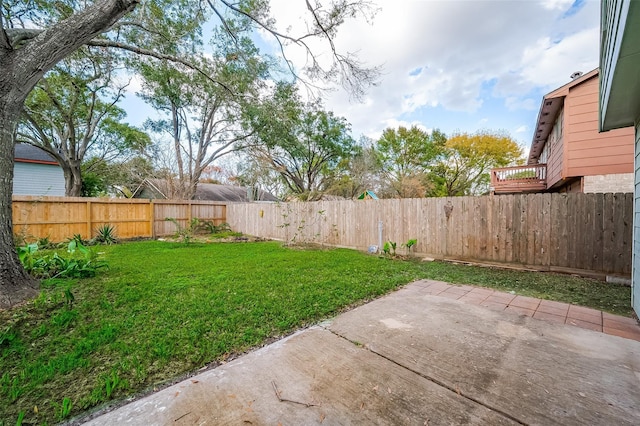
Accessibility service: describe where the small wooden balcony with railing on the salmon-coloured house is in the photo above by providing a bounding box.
[491,164,547,194]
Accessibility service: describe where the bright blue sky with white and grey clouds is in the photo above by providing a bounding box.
[123,0,600,150]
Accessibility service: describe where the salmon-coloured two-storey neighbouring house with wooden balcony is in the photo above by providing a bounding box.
[491,69,634,194]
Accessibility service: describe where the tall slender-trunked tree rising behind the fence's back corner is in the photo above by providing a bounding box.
[139,32,268,199]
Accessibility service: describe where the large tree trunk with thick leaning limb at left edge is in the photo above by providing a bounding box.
[0,0,140,308]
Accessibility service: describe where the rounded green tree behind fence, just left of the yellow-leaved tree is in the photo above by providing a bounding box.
[375,126,446,198]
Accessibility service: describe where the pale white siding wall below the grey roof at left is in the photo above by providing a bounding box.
[13,162,64,196]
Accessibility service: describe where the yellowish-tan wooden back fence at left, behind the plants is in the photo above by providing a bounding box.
[13,196,226,241]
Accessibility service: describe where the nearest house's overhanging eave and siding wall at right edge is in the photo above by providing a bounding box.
[599,0,640,315]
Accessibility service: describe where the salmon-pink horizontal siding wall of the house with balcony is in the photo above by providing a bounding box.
[563,76,634,178]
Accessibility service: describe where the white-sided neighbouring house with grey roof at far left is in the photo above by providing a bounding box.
[13,143,65,196]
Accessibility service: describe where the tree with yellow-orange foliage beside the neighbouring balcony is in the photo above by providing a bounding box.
[430,131,522,197]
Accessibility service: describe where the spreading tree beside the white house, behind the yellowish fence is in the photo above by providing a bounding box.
[17,48,150,197]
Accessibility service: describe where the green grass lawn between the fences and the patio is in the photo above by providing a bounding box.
[0,241,631,425]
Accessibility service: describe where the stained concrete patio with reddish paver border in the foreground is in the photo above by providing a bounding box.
[82,281,640,426]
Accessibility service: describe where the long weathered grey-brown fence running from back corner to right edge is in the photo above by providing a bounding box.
[227,194,633,275]
